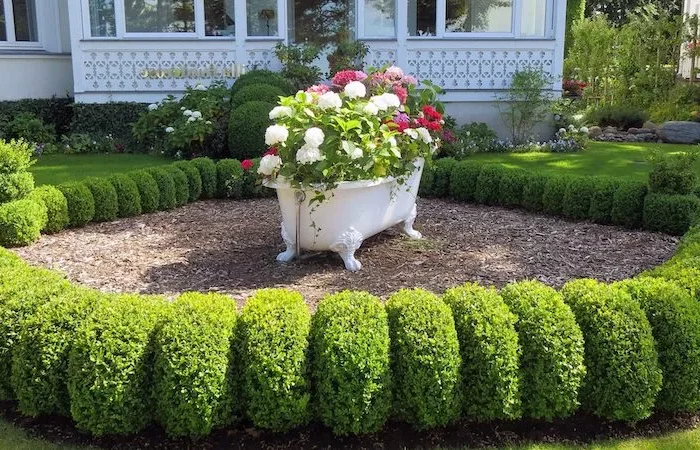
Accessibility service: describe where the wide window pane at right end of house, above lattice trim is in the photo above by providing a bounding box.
[446,0,513,33]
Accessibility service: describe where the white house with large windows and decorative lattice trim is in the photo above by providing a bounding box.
[0,0,566,129]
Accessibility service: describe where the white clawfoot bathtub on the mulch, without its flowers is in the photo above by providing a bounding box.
[265,159,424,272]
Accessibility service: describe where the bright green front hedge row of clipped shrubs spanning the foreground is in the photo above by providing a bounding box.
[0,248,700,437]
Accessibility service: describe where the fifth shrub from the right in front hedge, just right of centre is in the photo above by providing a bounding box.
[386,289,462,429]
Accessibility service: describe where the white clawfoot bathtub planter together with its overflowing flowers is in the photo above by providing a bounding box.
[258,66,443,271]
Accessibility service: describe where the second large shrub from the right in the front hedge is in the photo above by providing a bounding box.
[562,279,661,422]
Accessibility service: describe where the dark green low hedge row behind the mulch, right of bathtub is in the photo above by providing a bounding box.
[420,158,700,235]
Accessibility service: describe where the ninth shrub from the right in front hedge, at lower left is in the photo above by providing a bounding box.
[68,295,164,436]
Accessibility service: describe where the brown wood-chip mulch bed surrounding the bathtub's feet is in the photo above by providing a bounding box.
[15,199,678,307]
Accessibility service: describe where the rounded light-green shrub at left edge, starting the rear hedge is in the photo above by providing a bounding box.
[0,199,47,247]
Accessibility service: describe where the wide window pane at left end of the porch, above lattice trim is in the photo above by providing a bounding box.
[124,0,194,33]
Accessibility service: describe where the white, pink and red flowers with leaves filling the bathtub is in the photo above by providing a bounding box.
[258,66,444,197]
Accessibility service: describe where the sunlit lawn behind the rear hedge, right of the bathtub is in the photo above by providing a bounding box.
[469,142,700,181]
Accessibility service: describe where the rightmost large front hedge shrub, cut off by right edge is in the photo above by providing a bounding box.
[616,278,700,411]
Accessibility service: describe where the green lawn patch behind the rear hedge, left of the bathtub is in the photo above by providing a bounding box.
[31,154,172,185]
